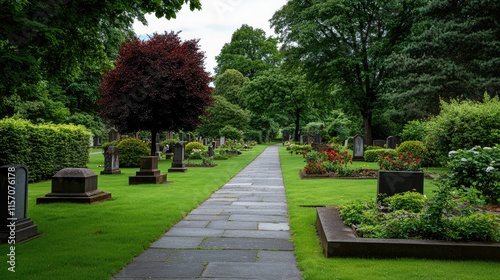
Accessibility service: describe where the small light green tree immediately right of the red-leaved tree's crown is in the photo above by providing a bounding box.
[214,69,250,109]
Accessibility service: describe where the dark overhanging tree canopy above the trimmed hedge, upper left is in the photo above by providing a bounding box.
[0,0,201,122]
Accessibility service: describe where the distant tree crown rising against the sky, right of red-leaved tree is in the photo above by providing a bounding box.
[215,24,281,79]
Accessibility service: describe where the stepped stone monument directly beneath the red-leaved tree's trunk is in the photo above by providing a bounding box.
[128,156,167,185]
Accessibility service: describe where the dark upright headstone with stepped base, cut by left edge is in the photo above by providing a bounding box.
[0,164,39,244]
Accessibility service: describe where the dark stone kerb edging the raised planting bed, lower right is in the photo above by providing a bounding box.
[316,207,500,262]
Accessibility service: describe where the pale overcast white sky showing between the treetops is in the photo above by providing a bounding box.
[133,0,287,74]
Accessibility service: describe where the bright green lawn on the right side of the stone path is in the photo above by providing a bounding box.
[280,148,500,280]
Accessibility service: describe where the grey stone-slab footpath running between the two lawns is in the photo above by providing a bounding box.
[112,146,302,280]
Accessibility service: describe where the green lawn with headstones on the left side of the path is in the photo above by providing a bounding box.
[0,145,267,279]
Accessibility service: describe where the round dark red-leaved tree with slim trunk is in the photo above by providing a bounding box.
[97,32,213,155]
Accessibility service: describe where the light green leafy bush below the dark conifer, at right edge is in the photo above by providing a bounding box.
[425,95,500,165]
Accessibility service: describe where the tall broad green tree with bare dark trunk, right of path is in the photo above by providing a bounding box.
[271,0,421,143]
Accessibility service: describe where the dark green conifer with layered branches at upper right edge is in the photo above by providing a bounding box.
[391,0,500,120]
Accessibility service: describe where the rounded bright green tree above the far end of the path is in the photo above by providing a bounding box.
[242,68,314,140]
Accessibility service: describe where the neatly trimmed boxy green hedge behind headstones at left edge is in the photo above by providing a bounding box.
[0,118,92,182]
